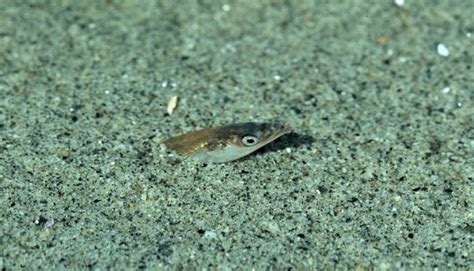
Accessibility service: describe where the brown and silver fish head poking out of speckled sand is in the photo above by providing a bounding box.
[164,122,291,163]
